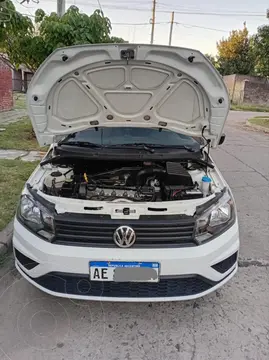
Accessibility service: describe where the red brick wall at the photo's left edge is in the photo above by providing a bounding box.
[0,60,13,111]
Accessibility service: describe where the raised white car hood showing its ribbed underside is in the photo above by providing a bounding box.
[27,44,229,146]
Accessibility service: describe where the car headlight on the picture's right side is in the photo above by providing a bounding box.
[195,192,235,244]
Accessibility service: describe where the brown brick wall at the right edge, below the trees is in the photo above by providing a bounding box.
[243,81,269,106]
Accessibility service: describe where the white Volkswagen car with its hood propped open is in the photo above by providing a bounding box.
[13,44,239,302]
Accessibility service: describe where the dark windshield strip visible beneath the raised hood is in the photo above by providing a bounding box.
[61,127,200,150]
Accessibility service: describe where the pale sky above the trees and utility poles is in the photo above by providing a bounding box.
[13,0,269,55]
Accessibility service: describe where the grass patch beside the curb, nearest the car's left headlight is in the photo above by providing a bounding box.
[0,160,38,230]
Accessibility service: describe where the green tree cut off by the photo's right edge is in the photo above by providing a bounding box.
[253,25,269,76]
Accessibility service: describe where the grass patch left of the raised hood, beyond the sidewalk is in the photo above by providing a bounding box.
[0,117,47,151]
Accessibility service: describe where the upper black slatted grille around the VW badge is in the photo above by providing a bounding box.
[54,213,196,248]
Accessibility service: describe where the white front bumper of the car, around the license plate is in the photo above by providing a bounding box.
[13,220,239,302]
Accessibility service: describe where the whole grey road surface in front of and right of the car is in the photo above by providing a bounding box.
[0,112,269,360]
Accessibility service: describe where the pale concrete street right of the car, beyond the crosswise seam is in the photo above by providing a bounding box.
[213,112,269,260]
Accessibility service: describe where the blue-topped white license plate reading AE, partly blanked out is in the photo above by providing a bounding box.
[89,261,160,282]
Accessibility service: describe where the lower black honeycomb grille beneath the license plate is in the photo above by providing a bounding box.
[29,273,215,298]
